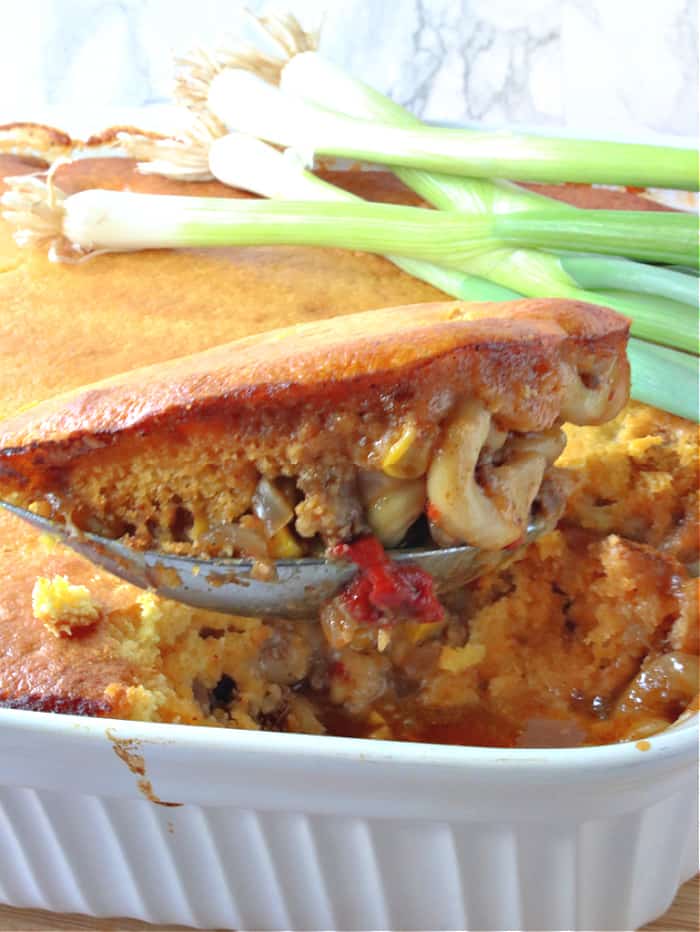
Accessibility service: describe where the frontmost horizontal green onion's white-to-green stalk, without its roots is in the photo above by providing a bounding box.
[15,190,697,270]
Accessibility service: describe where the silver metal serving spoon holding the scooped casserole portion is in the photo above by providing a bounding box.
[0,500,557,618]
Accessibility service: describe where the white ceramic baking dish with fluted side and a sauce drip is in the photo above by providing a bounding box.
[0,710,698,930]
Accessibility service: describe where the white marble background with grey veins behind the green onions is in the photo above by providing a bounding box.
[0,0,698,139]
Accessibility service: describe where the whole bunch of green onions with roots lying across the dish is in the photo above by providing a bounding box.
[3,10,700,419]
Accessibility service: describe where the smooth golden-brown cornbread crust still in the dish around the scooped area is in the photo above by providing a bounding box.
[0,157,442,715]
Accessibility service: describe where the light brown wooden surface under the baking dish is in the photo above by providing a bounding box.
[0,877,700,932]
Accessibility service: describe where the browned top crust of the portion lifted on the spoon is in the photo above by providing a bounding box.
[0,299,629,473]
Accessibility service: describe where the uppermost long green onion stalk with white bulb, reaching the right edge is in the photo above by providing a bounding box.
[208,69,699,191]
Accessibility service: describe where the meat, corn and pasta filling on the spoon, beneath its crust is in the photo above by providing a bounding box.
[23,398,564,560]
